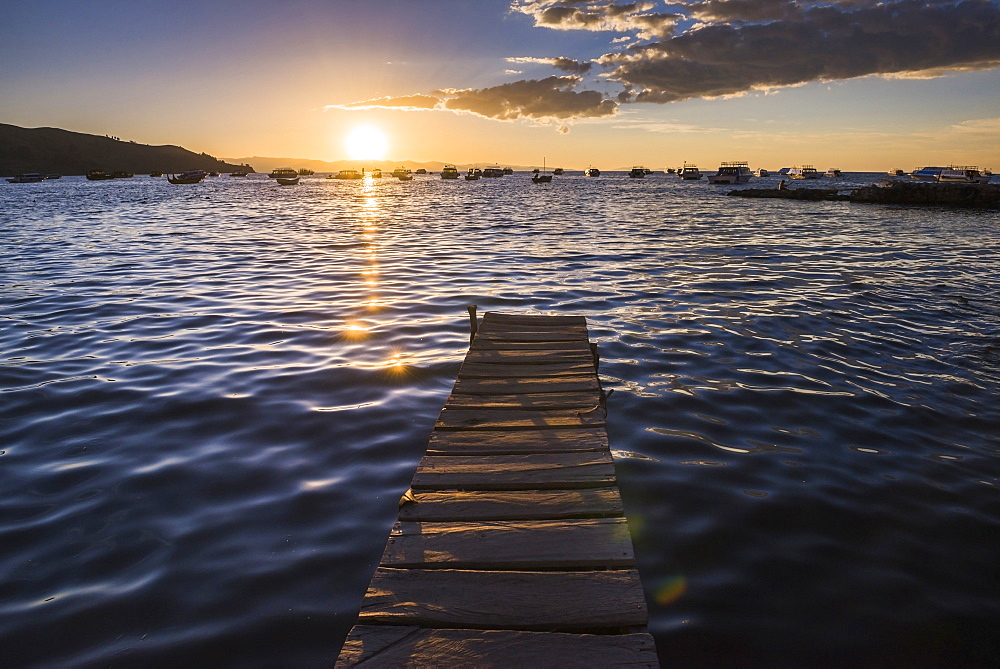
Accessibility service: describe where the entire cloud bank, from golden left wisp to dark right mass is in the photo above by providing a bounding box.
[338,0,1000,120]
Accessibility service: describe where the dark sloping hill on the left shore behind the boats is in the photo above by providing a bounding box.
[0,123,247,176]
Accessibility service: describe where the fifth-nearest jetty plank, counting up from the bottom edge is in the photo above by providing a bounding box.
[411,452,616,490]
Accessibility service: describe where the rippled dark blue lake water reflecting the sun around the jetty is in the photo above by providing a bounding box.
[0,173,1000,667]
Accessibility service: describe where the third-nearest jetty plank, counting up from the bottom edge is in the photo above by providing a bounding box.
[381,518,635,571]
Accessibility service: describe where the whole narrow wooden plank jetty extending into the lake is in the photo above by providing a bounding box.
[337,307,659,667]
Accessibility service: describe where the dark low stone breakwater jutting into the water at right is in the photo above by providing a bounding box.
[729,180,1000,209]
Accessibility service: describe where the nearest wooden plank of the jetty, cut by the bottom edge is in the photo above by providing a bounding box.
[336,625,659,669]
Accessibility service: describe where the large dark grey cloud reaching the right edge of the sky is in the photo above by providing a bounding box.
[599,0,1000,103]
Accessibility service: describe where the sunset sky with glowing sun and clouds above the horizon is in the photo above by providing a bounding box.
[0,0,1000,171]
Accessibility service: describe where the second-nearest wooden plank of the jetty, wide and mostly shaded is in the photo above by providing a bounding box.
[358,567,648,631]
